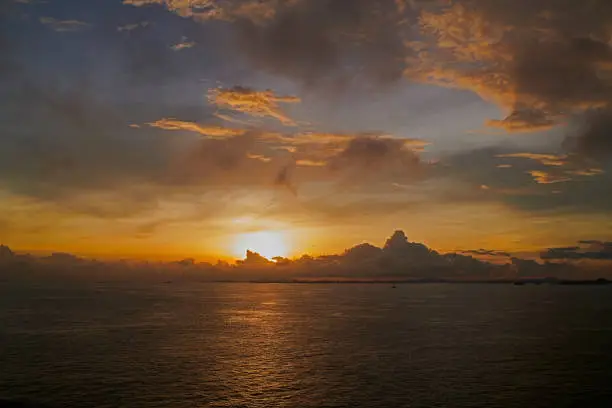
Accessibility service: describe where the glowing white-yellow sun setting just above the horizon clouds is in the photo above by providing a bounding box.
[232,231,289,259]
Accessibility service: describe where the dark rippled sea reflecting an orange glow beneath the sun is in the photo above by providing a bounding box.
[0,283,612,408]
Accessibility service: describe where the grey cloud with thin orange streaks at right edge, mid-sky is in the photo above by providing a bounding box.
[434,147,612,214]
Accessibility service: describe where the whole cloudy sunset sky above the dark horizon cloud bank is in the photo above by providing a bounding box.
[0,0,612,260]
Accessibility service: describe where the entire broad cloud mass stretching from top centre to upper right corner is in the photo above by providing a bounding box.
[124,0,612,155]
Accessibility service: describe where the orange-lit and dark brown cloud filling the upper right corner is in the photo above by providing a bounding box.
[408,0,612,131]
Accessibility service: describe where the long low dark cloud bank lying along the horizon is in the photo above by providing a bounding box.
[7,231,612,281]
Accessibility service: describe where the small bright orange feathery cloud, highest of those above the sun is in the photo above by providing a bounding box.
[208,86,300,126]
